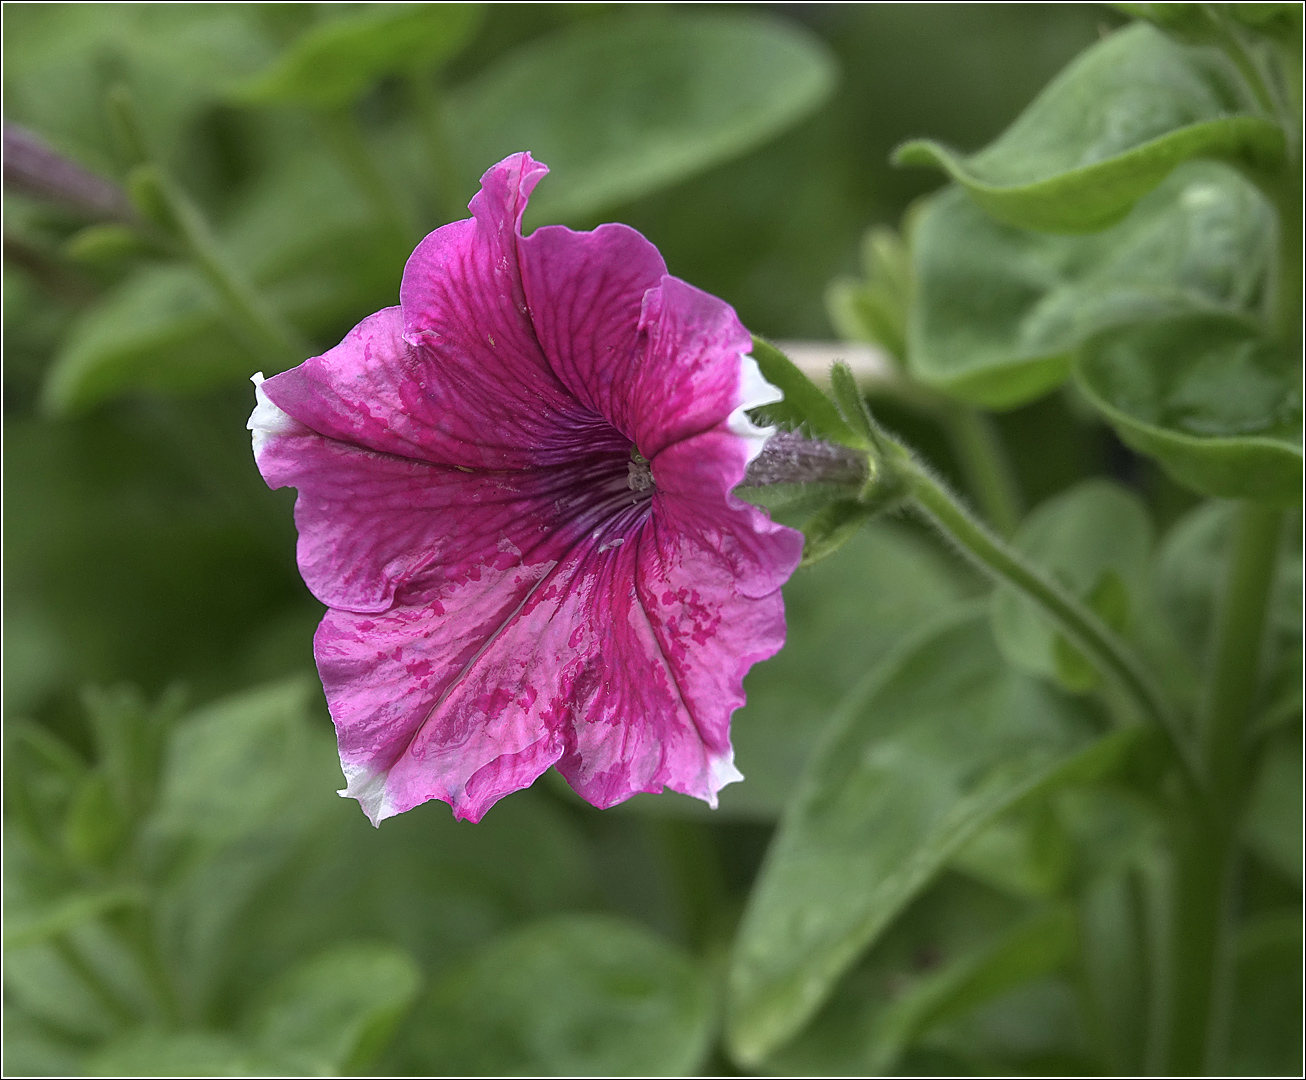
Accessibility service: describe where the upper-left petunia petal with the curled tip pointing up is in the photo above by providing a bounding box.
[264,167,599,469]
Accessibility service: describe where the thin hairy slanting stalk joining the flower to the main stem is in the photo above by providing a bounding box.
[895,447,1198,786]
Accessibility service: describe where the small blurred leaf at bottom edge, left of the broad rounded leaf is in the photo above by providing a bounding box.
[248,945,422,1076]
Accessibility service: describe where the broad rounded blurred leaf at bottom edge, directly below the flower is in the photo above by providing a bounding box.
[404,915,714,1076]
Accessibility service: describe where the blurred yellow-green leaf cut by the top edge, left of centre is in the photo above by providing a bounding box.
[234,4,482,108]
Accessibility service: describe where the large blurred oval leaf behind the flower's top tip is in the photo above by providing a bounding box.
[449,13,835,225]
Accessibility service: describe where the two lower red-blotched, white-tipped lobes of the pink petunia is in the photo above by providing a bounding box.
[326,485,801,820]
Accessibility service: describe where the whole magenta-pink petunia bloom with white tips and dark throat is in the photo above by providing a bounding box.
[249,154,802,824]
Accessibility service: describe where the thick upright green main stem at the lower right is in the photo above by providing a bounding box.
[1168,503,1284,1076]
